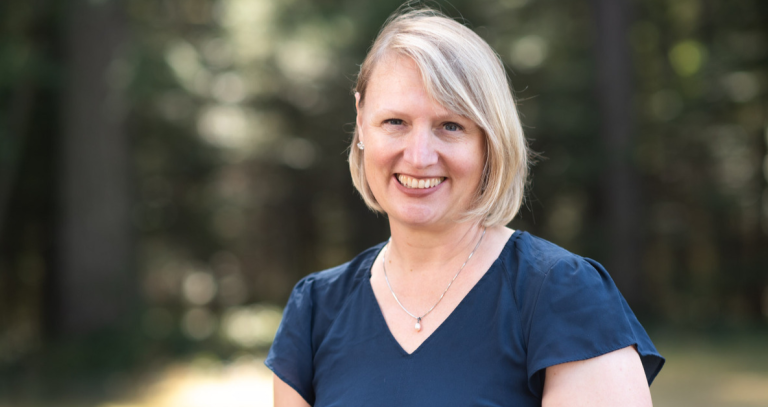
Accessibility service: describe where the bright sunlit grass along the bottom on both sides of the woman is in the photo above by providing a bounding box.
[0,332,768,407]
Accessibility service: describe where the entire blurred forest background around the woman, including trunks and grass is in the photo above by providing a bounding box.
[0,0,768,407]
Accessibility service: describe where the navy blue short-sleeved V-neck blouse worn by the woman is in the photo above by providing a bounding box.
[265,231,664,407]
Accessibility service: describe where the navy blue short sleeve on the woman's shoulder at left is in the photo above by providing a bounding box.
[264,276,315,405]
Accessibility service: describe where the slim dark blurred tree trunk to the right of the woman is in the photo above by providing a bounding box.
[593,0,642,304]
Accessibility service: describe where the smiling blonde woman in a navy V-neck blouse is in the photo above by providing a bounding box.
[266,10,663,407]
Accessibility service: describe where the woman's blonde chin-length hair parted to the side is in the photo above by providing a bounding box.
[349,7,529,226]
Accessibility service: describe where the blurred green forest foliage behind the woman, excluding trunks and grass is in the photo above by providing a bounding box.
[0,0,768,396]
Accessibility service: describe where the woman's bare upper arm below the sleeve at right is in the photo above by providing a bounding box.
[541,346,653,407]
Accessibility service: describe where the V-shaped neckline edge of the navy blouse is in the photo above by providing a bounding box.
[365,229,522,357]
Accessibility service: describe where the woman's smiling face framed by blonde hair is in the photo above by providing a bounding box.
[354,55,485,227]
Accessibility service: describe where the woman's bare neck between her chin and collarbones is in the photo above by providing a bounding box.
[387,221,484,277]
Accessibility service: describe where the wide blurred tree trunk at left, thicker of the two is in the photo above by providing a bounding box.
[52,0,134,336]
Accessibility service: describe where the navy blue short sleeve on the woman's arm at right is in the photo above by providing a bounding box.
[527,256,664,396]
